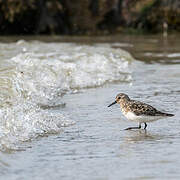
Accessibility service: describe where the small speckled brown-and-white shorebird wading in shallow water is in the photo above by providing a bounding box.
[108,93,174,130]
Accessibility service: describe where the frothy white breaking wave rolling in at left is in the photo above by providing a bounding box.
[0,41,132,150]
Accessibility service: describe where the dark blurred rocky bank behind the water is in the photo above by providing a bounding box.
[0,0,180,35]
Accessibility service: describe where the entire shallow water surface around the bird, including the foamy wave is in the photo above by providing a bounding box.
[0,35,180,180]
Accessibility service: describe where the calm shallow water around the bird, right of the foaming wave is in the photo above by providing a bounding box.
[0,36,180,180]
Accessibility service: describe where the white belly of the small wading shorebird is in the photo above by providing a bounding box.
[124,112,165,123]
